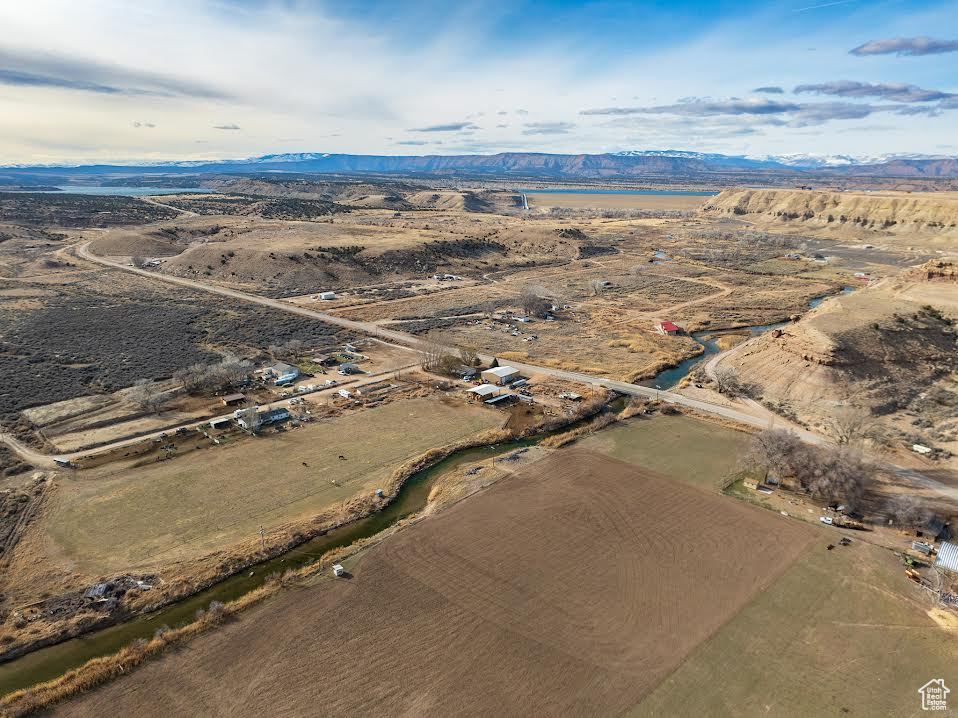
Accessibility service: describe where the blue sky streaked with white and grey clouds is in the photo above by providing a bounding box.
[0,0,958,164]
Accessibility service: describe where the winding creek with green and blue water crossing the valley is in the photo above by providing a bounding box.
[0,287,854,696]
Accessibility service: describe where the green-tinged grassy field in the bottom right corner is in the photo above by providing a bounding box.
[626,537,958,718]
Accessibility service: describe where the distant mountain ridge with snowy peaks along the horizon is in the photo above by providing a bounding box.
[0,150,958,180]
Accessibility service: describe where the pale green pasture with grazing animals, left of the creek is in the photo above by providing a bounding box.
[31,399,503,575]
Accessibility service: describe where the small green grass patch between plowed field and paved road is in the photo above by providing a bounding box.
[579,414,750,489]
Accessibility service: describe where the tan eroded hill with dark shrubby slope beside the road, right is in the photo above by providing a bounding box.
[720,280,958,447]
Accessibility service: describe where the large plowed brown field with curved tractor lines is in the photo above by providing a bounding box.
[59,449,813,717]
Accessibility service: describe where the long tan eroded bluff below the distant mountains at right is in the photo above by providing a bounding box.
[702,189,958,238]
